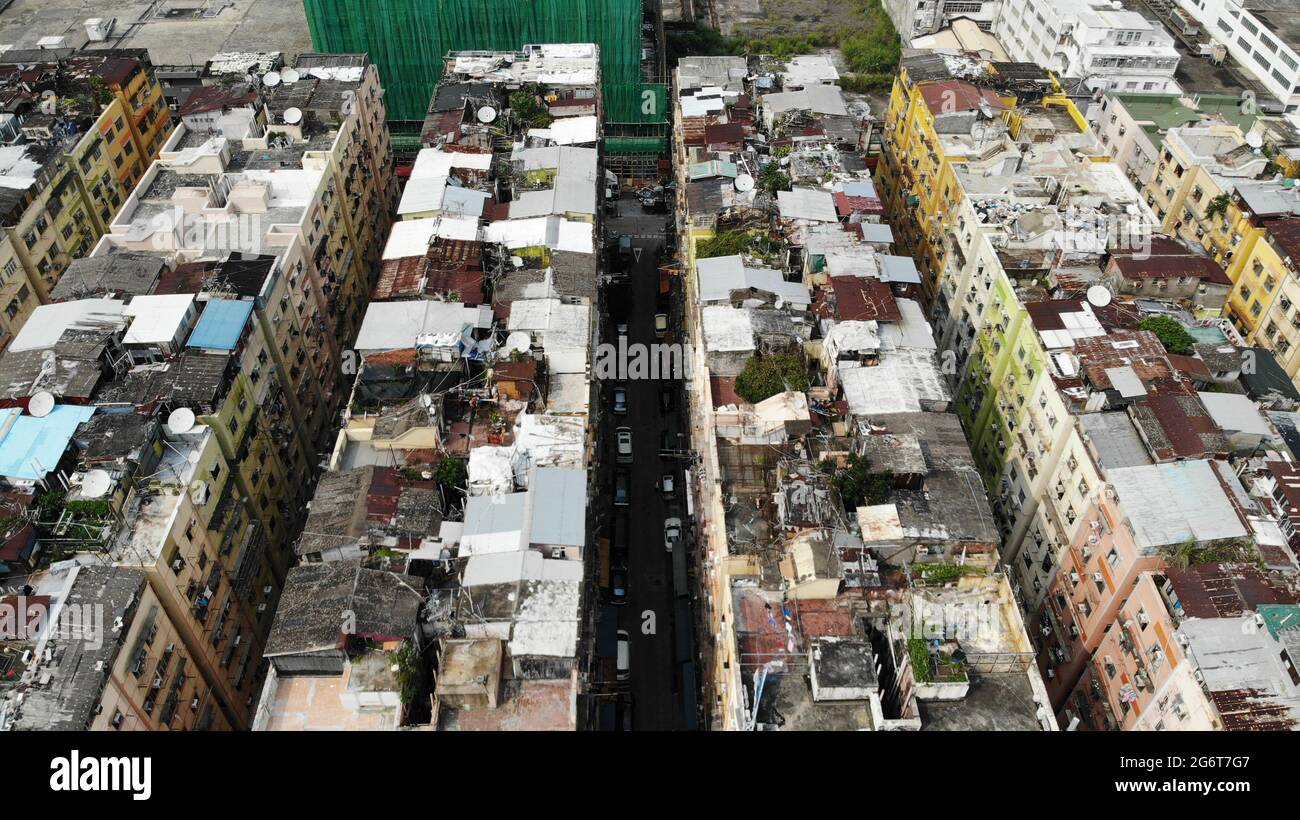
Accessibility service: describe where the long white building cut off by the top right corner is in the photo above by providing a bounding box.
[1178,0,1300,114]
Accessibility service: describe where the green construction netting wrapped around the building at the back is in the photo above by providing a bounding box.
[303,0,667,122]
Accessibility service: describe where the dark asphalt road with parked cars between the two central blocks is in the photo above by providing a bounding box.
[601,195,685,730]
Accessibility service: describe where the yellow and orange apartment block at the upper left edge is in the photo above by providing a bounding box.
[0,51,170,334]
